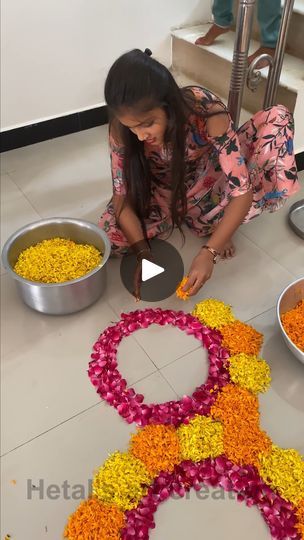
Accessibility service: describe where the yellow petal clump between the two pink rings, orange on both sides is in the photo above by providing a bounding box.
[177,415,224,461]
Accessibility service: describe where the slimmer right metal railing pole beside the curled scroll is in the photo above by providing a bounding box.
[263,0,294,108]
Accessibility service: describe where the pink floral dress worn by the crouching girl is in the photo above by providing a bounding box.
[99,86,299,253]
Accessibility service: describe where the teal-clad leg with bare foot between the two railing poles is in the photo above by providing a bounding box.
[248,0,282,69]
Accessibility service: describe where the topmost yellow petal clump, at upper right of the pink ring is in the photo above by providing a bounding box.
[192,298,235,328]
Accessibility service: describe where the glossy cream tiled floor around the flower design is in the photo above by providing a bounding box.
[1,127,304,540]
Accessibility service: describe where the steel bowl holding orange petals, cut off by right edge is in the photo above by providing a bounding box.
[277,278,304,364]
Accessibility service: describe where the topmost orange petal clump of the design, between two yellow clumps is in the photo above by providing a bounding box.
[220,321,263,355]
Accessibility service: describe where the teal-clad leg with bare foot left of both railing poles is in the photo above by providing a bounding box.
[195,0,233,46]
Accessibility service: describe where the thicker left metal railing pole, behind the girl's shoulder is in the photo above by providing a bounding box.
[228,0,255,127]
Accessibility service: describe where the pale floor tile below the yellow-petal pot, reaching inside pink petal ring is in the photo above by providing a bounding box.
[1,275,156,454]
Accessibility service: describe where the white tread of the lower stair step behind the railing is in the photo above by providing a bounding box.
[172,24,304,92]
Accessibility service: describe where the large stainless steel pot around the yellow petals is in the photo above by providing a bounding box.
[2,218,111,315]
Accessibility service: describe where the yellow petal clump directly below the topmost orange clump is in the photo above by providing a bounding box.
[229,353,271,394]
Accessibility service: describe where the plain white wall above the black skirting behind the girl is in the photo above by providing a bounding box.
[1,0,211,130]
